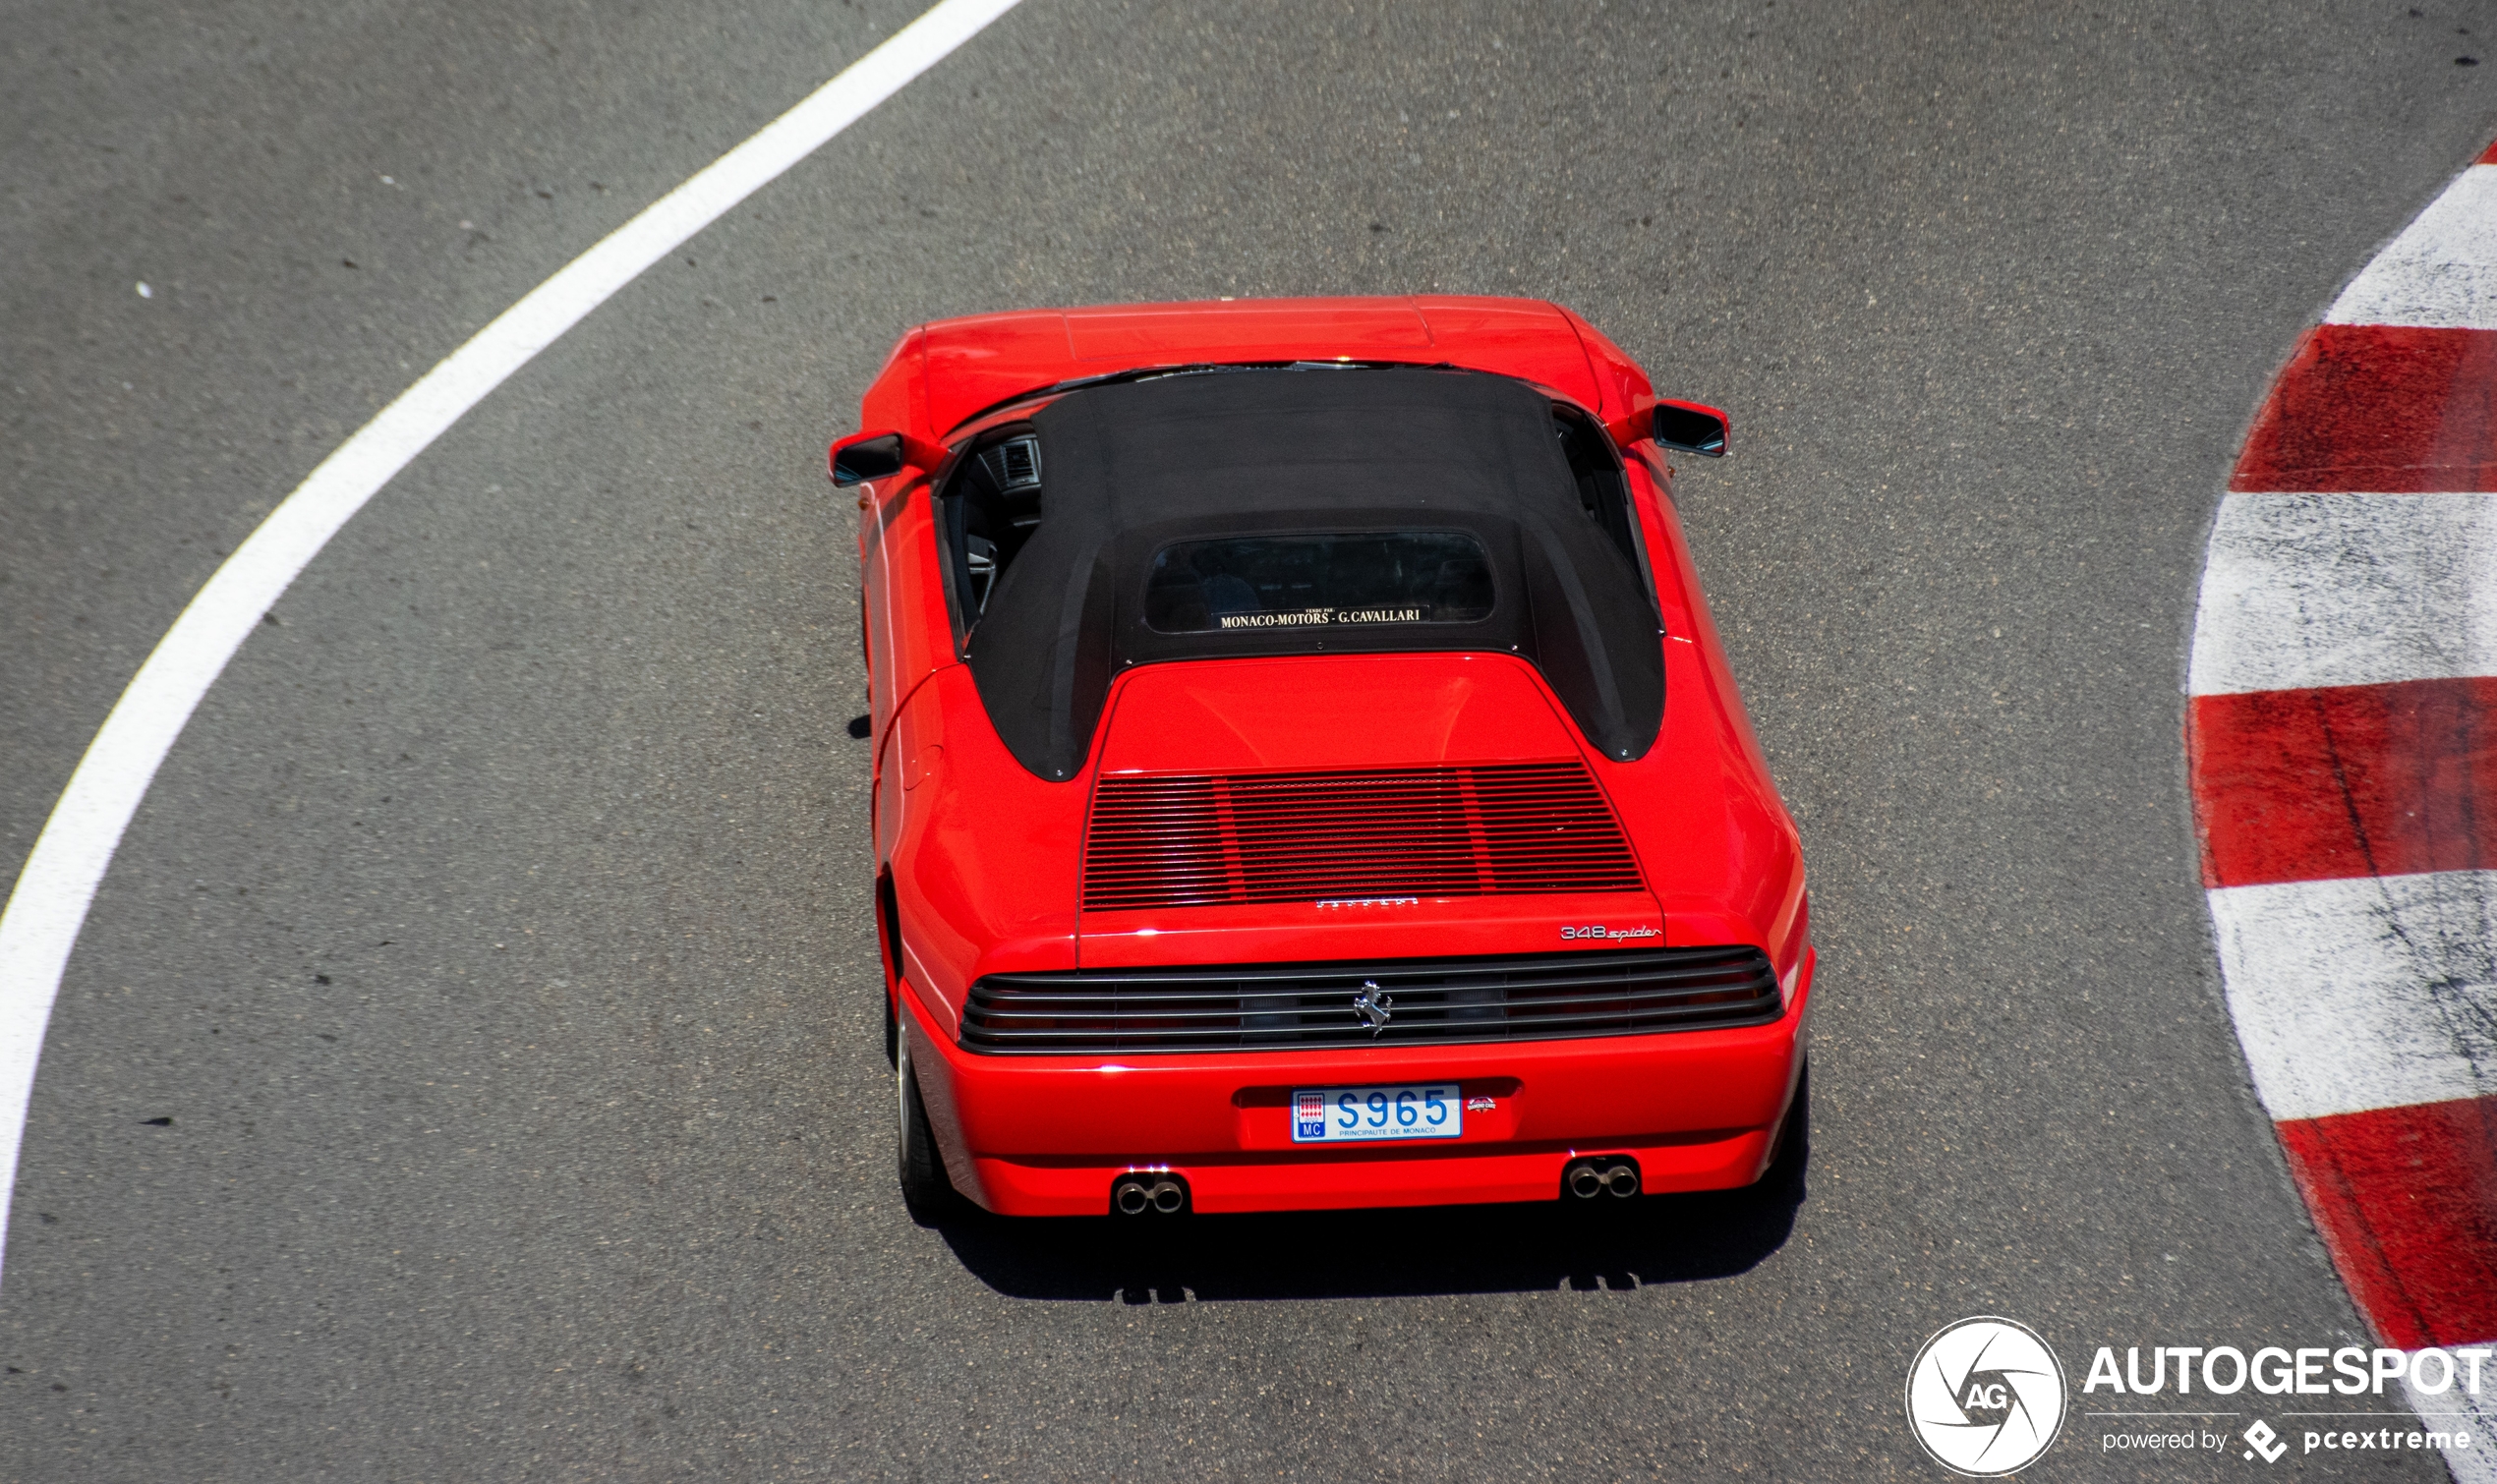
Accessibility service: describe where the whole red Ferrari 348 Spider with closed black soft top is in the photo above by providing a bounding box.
[832,298,1813,1220]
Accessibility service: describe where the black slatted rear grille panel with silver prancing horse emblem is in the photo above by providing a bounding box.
[961,946,1785,1056]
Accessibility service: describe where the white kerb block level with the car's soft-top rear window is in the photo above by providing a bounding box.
[2187,485,2497,695]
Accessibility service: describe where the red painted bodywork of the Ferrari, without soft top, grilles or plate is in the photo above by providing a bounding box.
[859,298,1816,1214]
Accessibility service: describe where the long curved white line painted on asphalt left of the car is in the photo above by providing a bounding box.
[0,0,1016,1279]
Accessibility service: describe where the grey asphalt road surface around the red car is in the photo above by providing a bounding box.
[0,0,2497,1481]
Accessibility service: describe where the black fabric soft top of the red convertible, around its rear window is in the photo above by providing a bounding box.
[969,368,1665,779]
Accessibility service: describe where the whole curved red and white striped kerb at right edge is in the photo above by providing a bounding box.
[2185,147,2497,1484]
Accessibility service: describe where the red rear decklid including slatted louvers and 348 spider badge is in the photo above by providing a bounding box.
[1078,655,1663,967]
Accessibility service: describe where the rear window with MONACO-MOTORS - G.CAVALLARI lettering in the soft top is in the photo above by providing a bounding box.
[1143,530,1490,635]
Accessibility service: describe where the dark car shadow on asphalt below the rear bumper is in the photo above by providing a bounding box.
[939,1134,1808,1304]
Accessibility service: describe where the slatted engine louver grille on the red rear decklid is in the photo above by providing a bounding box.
[1083,762,1641,912]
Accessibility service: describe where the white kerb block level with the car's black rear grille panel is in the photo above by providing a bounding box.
[2210,872,2497,1121]
